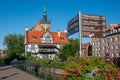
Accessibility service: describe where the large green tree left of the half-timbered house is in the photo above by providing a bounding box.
[4,34,24,60]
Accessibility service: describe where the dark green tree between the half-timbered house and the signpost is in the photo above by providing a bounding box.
[59,38,79,60]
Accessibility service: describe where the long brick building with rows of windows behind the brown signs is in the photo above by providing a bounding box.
[91,24,120,57]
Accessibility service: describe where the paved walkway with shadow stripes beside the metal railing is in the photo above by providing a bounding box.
[0,66,37,80]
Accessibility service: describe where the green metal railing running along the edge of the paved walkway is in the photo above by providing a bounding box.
[13,60,64,80]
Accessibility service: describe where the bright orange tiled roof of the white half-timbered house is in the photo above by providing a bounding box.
[27,30,68,44]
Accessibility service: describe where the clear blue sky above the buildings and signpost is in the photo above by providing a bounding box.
[0,0,120,49]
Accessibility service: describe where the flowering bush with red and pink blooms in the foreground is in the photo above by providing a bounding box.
[64,57,120,80]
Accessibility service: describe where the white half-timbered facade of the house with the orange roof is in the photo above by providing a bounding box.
[25,29,62,60]
